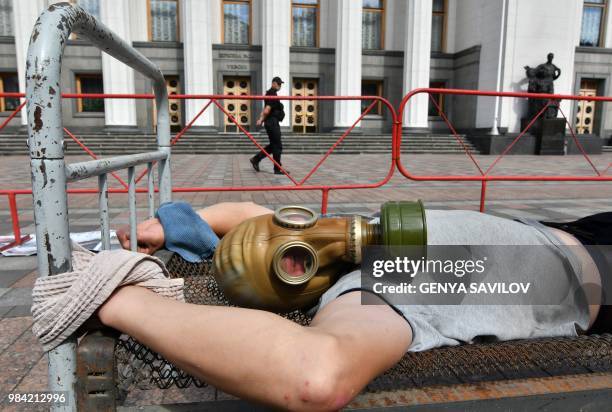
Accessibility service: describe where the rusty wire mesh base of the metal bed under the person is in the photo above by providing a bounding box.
[77,254,612,408]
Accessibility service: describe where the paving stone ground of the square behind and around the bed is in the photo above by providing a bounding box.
[0,154,612,410]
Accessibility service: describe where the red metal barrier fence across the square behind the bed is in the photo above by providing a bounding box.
[0,88,612,250]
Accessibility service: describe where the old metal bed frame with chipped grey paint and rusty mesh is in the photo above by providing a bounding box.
[27,3,612,410]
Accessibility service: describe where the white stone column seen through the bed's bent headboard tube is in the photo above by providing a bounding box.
[100,0,137,127]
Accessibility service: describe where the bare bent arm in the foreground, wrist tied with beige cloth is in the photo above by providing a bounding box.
[99,286,412,410]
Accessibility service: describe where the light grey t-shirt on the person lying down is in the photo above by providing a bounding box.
[318,210,589,352]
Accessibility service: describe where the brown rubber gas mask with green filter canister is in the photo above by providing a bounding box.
[213,200,427,312]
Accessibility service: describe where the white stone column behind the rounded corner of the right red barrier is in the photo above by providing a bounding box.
[402,0,432,129]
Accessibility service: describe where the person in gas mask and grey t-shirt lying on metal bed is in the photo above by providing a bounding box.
[32,202,612,411]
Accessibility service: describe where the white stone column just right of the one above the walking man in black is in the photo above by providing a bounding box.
[334,0,362,129]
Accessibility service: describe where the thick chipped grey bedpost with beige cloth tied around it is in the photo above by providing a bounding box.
[26,7,76,411]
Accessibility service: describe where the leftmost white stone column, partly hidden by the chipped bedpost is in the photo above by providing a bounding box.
[13,0,45,126]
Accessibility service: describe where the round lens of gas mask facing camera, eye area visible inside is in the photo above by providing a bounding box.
[273,241,319,285]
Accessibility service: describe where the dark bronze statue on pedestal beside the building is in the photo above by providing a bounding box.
[525,53,561,119]
